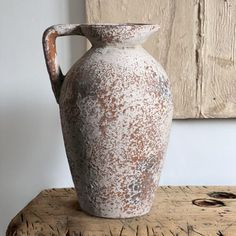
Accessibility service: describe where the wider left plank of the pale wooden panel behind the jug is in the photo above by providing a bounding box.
[86,0,199,118]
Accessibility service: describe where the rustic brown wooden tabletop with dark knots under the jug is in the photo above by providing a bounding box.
[7,186,236,236]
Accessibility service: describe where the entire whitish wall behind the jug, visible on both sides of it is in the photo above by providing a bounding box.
[0,0,236,235]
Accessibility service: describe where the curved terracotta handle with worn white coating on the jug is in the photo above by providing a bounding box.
[43,24,84,103]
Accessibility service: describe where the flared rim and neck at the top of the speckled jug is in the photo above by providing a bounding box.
[81,24,159,46]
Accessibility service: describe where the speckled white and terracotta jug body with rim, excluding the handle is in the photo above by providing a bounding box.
[42,24,173,218]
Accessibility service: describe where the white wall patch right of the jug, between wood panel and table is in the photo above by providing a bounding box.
[160,119,236,185]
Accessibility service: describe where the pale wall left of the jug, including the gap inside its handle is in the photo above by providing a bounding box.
[0,0,85,235]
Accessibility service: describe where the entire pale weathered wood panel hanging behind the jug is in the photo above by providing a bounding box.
[86,0,236,119]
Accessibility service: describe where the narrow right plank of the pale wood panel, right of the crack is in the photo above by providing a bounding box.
[201,0,236,118]
